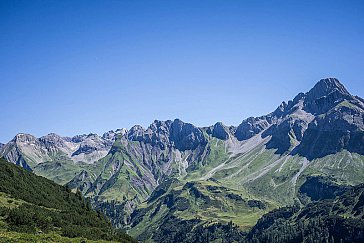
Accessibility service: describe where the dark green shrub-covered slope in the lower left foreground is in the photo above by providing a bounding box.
[0,159,134,242]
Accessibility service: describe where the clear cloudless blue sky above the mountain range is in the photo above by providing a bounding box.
[0,0,364,143]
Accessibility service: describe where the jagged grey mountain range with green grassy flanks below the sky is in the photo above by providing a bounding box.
[0,78,364,242]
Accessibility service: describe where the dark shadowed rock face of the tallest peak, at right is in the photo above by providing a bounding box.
[296,78,364,159]
